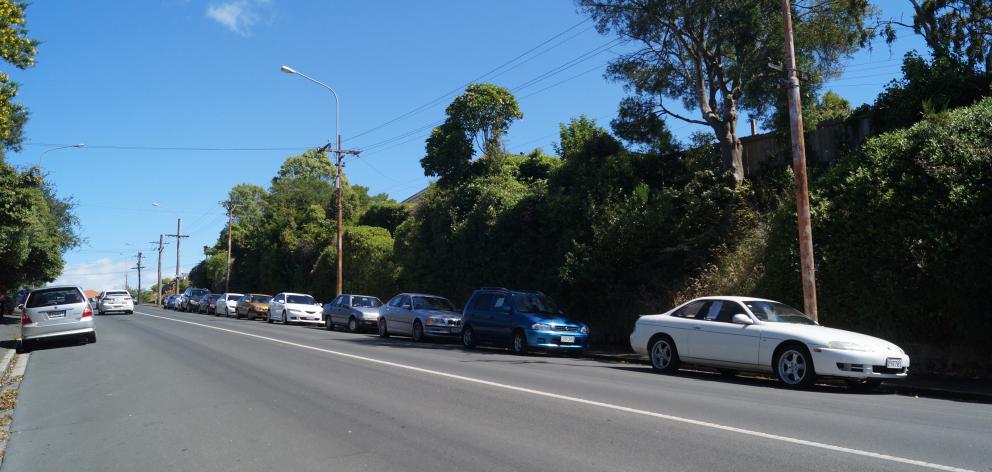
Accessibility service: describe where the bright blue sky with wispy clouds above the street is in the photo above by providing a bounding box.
[8,0,922,289]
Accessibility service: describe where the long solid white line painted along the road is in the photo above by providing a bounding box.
[135,311,976,472]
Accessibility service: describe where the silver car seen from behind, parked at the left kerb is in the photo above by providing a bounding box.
[20,285,96,350]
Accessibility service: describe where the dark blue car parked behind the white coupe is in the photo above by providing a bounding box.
[462,287,589,354]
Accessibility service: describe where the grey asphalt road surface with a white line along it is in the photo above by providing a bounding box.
[2,307,992,472]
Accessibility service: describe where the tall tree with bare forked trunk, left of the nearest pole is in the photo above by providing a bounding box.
[578,0,874,184]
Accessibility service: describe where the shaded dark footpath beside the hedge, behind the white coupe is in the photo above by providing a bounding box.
[585,347,992,403]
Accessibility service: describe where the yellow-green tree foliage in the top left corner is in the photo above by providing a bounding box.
[0,0,38,155]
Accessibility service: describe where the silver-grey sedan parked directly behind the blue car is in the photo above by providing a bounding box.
[378,293,462,341]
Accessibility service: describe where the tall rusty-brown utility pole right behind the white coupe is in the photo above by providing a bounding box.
[782,0,818,321]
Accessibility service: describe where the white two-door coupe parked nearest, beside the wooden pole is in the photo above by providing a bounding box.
[630,297,909,389]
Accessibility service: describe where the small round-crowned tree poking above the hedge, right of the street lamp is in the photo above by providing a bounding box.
[420,84,523,179]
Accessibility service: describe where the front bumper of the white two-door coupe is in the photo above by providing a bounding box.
[811,348,909,380]
